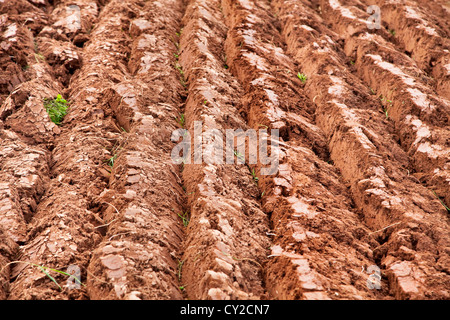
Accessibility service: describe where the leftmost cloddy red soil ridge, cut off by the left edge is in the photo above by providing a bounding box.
[0,1,85,298]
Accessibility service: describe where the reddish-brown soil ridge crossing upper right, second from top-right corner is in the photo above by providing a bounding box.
[320,0,450,98]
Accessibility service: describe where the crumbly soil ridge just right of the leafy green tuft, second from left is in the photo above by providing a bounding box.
[4,1,110,299]
